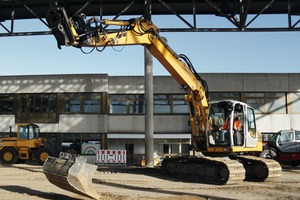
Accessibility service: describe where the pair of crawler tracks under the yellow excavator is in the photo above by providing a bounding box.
[161,156,282,185]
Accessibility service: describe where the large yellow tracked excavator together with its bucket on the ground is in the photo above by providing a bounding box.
[43,7,282,198]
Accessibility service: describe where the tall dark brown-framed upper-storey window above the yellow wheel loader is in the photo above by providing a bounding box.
[17,94,57,123]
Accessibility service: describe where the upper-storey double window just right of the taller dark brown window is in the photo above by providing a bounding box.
[61,93,102,113]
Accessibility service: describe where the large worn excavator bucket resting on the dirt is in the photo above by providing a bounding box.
[43,152,100,199]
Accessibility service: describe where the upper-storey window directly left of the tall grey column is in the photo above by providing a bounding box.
[109,94,145,114]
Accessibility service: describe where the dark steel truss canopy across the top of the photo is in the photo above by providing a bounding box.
[0,0,300,37]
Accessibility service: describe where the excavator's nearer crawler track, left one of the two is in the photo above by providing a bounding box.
[162,157,245,185]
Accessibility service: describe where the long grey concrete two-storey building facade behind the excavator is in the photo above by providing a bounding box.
[0,73,300,164]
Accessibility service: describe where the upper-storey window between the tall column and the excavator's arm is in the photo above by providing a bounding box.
[153,94,189,114]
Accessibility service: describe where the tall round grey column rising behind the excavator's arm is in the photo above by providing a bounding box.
[144,0,154,167]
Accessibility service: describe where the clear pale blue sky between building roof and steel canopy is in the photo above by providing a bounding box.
[0,16,300,76]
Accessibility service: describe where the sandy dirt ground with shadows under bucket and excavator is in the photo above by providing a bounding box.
[0,164,300,200]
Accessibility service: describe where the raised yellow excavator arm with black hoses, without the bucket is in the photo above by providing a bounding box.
[46,8,208,150]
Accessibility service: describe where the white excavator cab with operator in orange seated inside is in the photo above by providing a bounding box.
[206,100,262,153]
